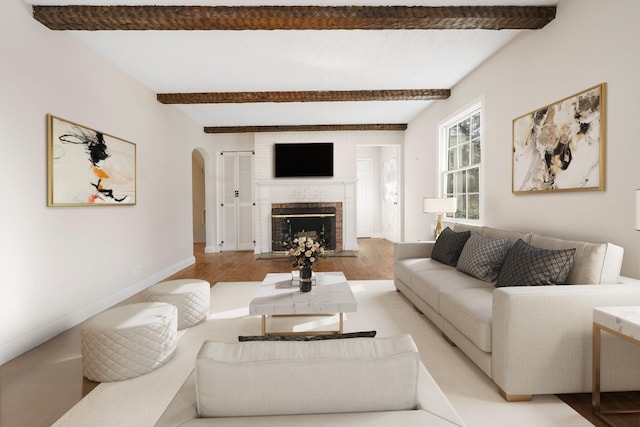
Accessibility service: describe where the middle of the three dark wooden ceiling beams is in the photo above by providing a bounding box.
[156,89,451,104]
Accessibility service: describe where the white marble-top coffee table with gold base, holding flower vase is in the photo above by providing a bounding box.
[249,272,358,336]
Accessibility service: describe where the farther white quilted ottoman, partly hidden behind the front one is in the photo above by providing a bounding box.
[145,279,211,329]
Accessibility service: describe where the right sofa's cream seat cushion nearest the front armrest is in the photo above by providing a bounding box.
[440,287,494,353]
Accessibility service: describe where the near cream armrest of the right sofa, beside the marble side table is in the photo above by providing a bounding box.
[491,282,640,395]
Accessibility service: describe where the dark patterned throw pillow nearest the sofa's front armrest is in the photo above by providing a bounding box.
[496,240,576,288]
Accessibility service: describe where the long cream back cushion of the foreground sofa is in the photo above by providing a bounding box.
[195,334,420,417]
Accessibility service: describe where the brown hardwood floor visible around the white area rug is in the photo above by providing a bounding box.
[0,239,640,427]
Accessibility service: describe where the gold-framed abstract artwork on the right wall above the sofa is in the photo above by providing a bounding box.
[511,83,606,193]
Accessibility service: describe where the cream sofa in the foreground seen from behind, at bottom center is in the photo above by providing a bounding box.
[156,334,464,427]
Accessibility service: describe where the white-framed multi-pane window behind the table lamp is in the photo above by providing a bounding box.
[440,105,482,221]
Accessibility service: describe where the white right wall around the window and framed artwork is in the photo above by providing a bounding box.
[404,0,640,278]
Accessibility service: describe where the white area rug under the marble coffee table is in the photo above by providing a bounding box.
[54,280,591,427]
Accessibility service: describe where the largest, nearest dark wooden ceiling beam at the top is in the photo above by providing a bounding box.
[33,5,556,31]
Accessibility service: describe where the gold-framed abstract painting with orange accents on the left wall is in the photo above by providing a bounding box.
[47,115,136,206]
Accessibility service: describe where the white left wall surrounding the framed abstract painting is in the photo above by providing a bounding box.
[0,0,206,363]
